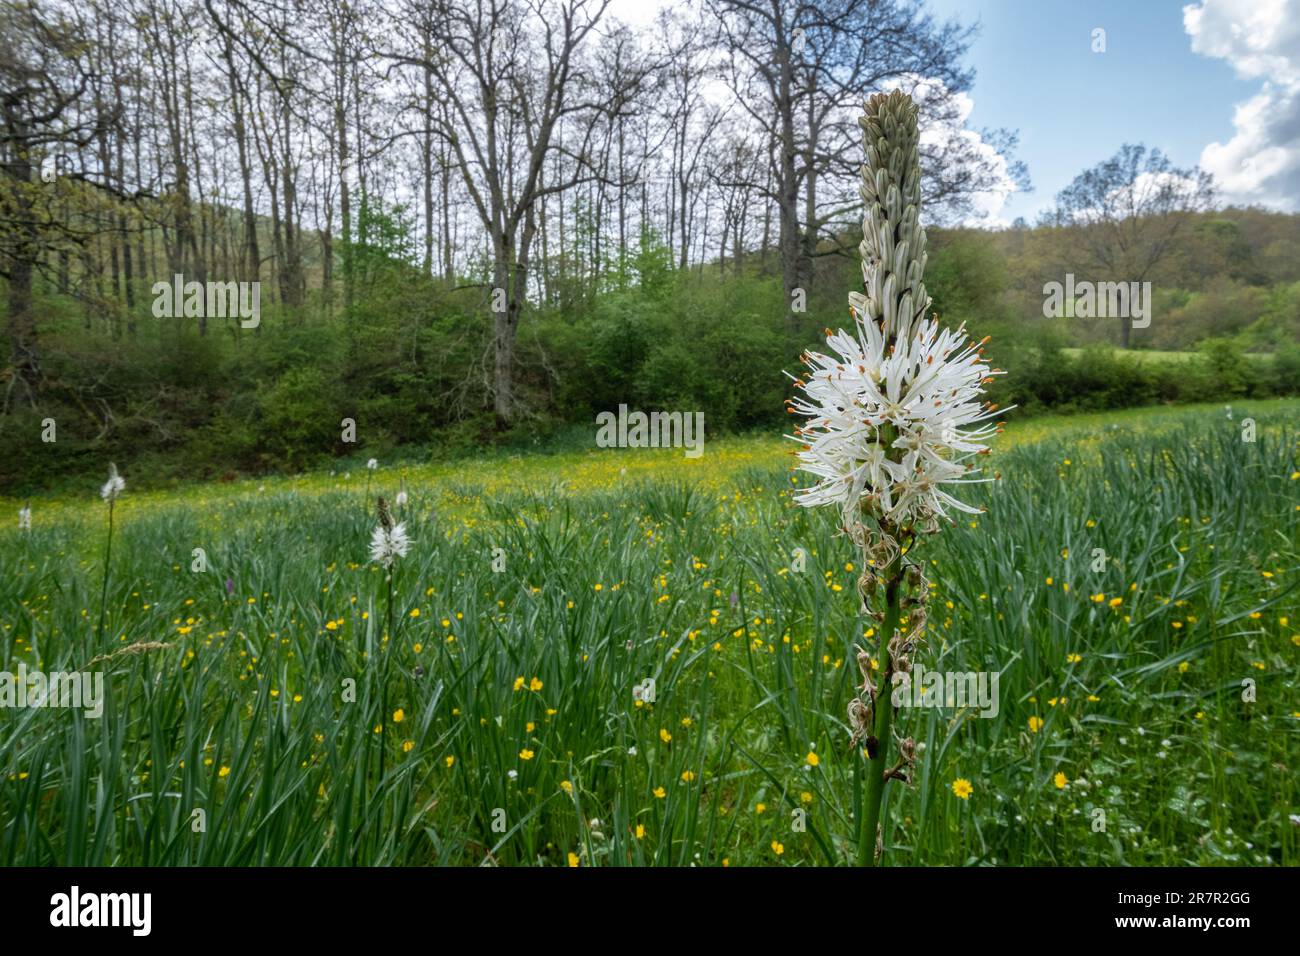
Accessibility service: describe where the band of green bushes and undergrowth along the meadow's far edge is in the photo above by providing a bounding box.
[0,205,1300,494]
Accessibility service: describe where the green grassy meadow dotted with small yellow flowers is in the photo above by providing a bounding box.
[0,401,1300,866]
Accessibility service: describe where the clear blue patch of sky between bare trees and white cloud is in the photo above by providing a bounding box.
[931,0,1260,222]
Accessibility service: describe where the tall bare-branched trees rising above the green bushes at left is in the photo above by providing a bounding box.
[4,0,1009,403]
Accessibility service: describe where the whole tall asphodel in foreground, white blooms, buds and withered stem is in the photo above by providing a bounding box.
[787,91,1000,865]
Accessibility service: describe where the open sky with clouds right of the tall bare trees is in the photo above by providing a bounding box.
[611,0,1300,225]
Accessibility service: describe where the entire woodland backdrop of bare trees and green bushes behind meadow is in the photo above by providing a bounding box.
[0,0,1300,489]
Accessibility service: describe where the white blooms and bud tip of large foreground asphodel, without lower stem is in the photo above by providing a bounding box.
[788,92,1001,531]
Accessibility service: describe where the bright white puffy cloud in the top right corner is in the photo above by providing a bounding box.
[1183,0,1300,211]
